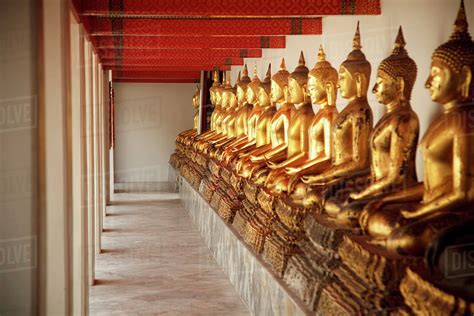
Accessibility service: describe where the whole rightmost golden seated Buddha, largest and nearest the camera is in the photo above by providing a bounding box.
[360,2,474,256]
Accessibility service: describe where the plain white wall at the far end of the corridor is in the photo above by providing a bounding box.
[114,83,196,183]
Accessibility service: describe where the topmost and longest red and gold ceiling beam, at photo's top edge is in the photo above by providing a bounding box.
[83,0,380,17]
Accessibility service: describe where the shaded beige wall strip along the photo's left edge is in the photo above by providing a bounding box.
[0,0,38,315]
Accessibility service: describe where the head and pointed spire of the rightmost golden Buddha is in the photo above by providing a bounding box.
[425,1,474,104]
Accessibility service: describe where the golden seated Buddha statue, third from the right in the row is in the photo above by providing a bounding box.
[301,23,373,208]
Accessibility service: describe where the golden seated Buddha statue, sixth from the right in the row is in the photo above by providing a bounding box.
[236,59,294,179]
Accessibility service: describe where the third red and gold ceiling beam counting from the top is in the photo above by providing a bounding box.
[92,35,286,49]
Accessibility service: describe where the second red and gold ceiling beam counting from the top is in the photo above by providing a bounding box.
[84,17,322,36]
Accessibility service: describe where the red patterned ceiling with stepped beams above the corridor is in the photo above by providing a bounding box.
[73,0,380,82]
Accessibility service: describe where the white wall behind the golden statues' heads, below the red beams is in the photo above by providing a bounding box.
[231,0,474,179]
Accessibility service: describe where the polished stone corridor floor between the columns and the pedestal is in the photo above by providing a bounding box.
[90,193,249,315]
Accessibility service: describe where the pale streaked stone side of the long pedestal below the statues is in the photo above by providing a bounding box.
[180,177,310,315]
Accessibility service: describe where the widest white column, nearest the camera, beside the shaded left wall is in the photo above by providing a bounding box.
[38,0,72,315]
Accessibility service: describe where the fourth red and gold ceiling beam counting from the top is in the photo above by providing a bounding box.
[99,48,262,61]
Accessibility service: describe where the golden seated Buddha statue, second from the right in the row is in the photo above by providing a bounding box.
[325,27,420,226]
